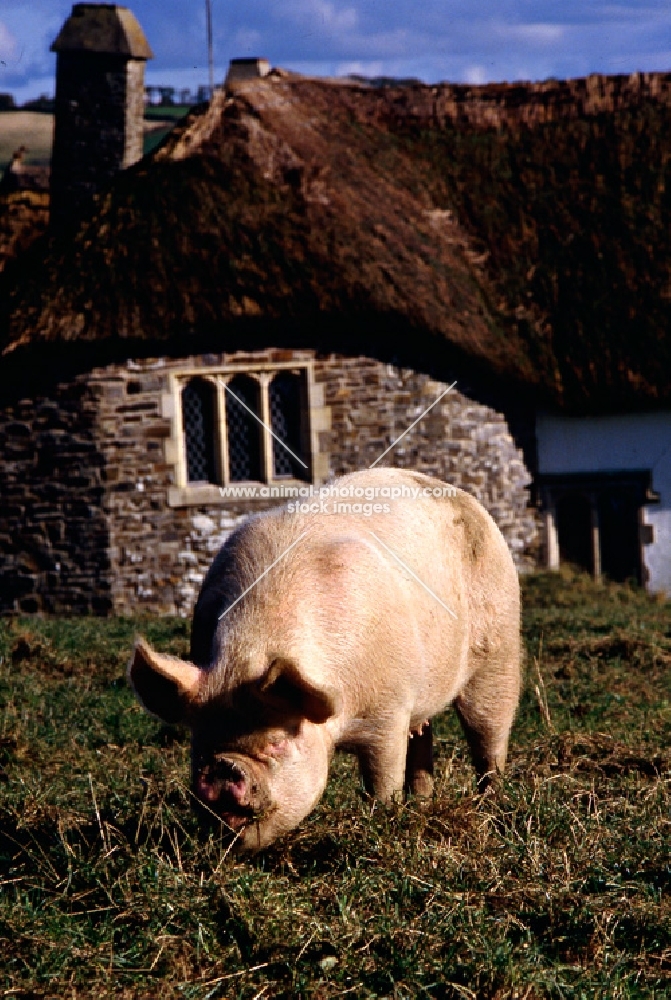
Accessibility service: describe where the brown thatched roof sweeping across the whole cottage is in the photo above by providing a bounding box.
[0,73,671,410]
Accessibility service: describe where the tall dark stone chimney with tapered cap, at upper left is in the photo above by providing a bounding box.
[51,3,153,229]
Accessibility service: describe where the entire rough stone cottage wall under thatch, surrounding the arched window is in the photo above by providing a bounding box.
[0,351,538,615]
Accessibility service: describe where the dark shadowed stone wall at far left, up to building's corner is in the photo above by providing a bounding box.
[0,380,112,614]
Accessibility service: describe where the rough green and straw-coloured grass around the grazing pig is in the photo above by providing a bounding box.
[0,575,671,1000]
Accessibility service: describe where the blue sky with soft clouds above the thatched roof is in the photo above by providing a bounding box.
[0,0,671,101]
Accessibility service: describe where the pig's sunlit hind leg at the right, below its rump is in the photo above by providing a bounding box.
[454,657,519,791]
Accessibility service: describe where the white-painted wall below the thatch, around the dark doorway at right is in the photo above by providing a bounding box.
[536,412,671,594]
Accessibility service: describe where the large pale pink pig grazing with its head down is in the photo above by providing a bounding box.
[129,469,520,850]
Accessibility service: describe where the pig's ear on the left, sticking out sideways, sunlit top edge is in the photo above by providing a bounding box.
[128,639,203,723]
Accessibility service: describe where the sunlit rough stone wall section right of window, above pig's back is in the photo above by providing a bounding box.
[317,357,540,570]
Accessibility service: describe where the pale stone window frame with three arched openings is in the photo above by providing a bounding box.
[168,359,323,506]
